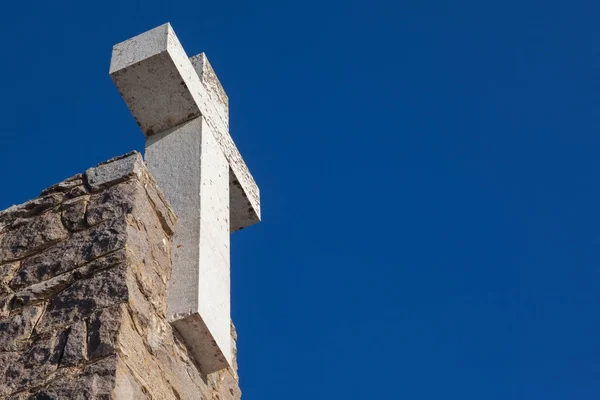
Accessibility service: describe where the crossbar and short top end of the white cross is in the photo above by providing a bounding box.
[110,23,260,232]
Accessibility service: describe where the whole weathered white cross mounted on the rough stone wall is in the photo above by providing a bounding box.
[110,23,260,373]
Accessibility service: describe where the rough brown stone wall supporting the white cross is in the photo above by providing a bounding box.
[0,153,241,400]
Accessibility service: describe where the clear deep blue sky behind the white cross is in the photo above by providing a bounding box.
[0,0,600,400]
